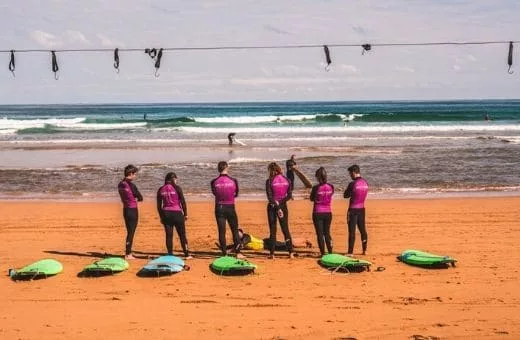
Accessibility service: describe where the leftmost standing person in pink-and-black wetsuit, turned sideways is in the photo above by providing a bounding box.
[117,164,143,260]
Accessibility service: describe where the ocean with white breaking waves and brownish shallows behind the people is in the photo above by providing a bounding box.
[0,100,520,199]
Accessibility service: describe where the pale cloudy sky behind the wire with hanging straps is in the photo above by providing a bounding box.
[0,0,520,104]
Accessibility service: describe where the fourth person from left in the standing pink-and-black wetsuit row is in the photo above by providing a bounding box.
[265,162,294,259]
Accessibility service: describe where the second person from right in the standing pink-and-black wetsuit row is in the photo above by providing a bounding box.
[310,167,334,256]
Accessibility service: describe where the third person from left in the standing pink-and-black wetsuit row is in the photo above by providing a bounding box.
[211,161,243,258]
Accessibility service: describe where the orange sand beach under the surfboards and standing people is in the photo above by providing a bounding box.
[0,197,520,339]
